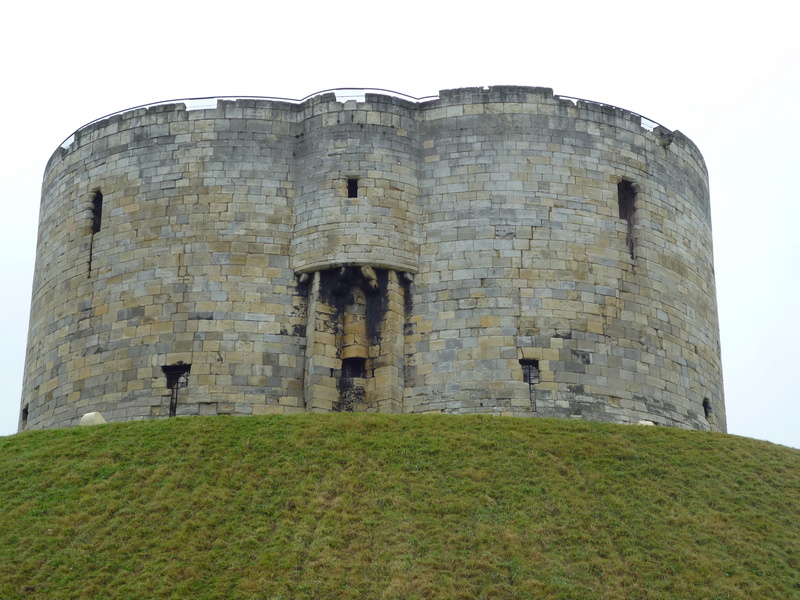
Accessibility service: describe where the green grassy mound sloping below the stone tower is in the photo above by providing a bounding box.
[0,414,800,600]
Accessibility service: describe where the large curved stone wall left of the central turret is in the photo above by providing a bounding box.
[23,101,304,426]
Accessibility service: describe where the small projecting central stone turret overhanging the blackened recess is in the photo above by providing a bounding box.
[292,94,420,272]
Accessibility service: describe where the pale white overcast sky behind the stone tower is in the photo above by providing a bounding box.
[0,0,800,448]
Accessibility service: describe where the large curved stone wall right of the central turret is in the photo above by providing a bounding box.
[406,88,724,428]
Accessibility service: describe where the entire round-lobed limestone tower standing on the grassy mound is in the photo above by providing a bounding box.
[19,87,726,431]
